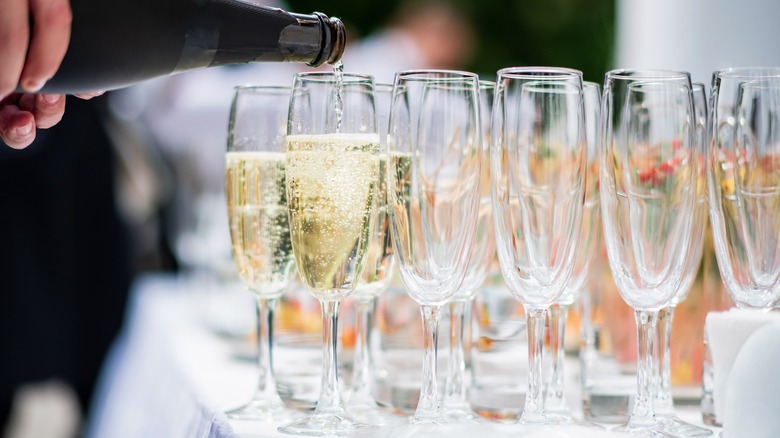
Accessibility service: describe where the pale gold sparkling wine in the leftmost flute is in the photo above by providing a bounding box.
[225,152,293,297]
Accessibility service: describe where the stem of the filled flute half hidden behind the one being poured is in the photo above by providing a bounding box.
[349,298,376,404]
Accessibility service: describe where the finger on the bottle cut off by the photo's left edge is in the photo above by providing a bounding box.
[0,0,30,100]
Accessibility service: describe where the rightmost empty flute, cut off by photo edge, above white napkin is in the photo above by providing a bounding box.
[707,68,780,310]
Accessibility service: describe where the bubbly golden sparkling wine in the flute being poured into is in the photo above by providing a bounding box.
[287,134,380,300]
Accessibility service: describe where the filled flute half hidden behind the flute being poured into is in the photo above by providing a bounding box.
[346,84,395,426]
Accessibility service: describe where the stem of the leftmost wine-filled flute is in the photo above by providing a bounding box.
[253,297,282,403]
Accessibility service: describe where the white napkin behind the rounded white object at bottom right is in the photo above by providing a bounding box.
[704,308,780,421]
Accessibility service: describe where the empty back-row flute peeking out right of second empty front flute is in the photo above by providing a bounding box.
[544,82,601,426]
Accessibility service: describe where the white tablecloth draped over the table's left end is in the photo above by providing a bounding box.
[87,276,239,438]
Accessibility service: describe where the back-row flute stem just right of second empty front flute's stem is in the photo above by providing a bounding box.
[544,304,569,413]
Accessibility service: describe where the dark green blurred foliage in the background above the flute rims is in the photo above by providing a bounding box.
[287,0,615,83]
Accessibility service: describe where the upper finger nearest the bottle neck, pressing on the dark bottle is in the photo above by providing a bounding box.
[19,0,73,92]
